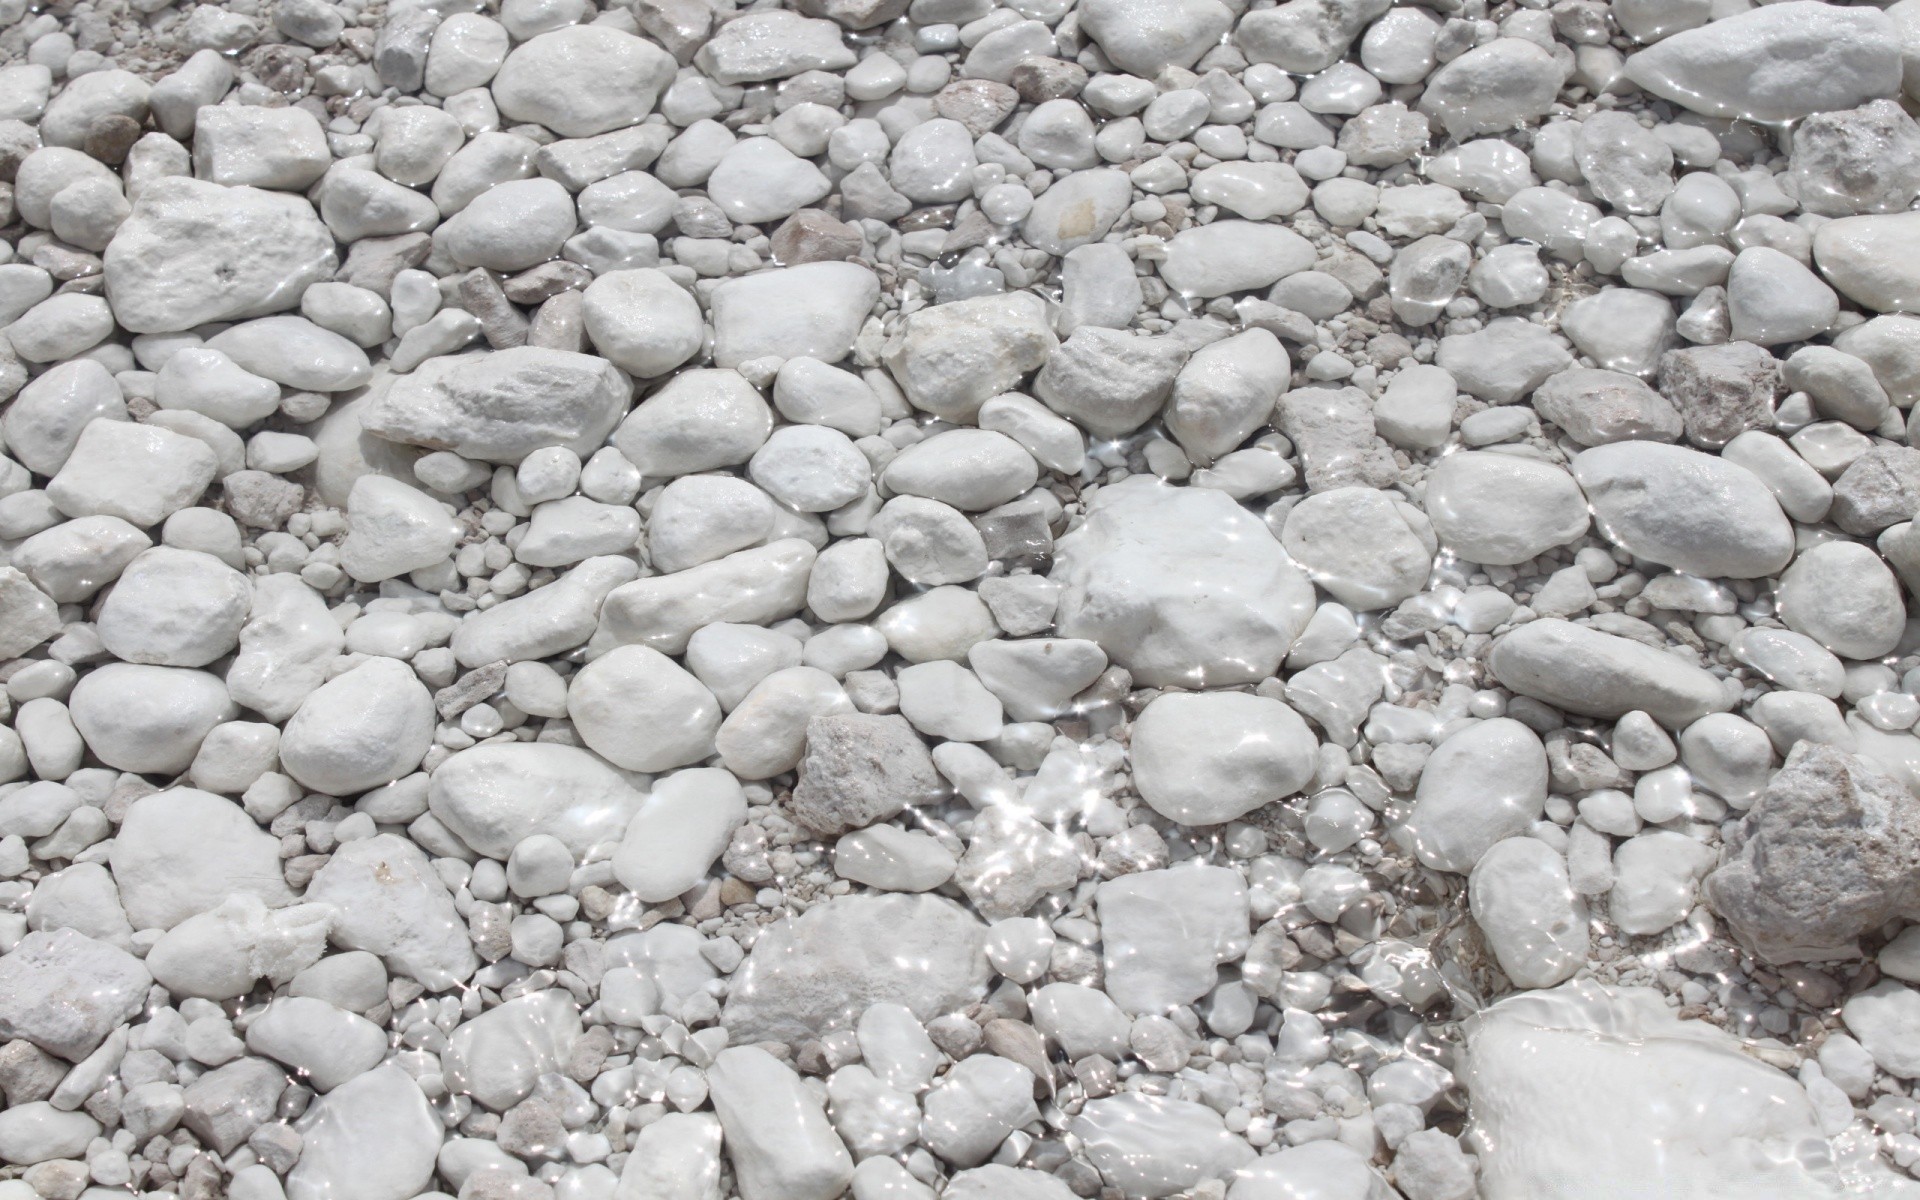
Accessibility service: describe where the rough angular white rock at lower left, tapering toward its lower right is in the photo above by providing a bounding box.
[307,833,480,991]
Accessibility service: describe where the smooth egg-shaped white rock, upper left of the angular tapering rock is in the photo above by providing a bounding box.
[280,657,436,795]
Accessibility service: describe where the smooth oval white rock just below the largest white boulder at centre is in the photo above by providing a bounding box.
[1131,691,1319,826]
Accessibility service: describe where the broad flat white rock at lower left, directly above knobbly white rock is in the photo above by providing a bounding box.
[108,787,294,929]
